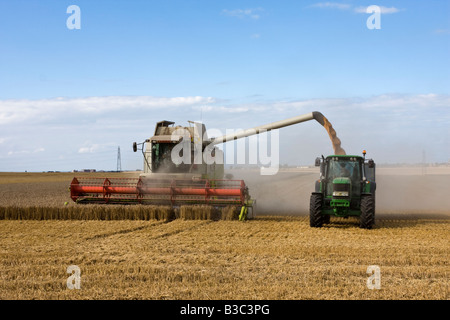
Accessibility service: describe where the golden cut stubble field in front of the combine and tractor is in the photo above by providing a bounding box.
[0,174,450,300]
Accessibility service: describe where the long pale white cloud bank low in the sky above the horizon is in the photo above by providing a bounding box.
[0,93,450,171]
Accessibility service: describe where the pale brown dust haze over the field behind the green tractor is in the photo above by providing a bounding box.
[227,167,450,218]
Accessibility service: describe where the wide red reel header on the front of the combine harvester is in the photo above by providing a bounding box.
[70,177,254,220]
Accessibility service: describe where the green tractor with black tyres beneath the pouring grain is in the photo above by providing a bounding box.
[309,151,376,229]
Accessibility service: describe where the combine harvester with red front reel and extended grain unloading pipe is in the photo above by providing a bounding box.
[70,112,326,220]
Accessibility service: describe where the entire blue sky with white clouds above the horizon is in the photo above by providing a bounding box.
[0,0,450,171]
